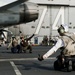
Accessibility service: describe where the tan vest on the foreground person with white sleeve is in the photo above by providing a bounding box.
[61,33,75,56]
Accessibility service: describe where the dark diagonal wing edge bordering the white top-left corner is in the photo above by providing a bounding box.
[0,0,28,12]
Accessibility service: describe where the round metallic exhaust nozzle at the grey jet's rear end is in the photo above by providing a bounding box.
[20,2,39,23]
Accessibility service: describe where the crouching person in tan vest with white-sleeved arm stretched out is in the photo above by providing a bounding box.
[38,25,75,71]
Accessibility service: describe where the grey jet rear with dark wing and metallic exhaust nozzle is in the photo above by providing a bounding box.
[0,0,38,39]
